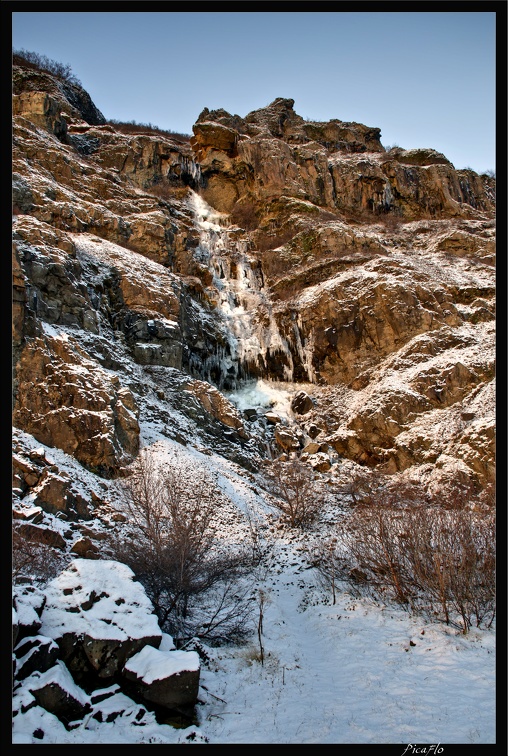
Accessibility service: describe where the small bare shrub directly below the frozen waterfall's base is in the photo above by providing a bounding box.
[265,459,324,528]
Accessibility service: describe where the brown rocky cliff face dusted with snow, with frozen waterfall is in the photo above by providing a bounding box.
[13,66,495,508]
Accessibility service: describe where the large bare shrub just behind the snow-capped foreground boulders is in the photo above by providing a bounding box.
[111,451,252,642]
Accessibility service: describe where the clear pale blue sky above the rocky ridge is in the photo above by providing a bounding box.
[12,9,496,173]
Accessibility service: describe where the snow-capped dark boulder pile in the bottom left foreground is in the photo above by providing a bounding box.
[13,559,200,729]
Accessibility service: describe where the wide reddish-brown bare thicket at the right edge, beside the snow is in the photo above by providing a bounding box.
[332,484,496,633]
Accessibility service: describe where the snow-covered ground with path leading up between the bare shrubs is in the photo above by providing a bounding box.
[13,427,496,744]
